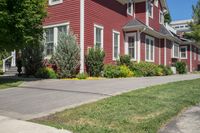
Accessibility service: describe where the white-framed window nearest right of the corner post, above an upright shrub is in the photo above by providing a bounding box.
[94,24,104,49]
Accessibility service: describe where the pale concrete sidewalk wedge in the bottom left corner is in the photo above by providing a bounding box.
[0,116,70,133]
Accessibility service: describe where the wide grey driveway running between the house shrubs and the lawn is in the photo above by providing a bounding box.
[0,74,200,120]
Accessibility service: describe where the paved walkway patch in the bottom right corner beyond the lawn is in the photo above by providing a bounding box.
[159,106,200,133]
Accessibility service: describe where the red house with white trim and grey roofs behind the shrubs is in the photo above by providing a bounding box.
[44,0,200,72]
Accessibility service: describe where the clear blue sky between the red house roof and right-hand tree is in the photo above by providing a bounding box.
[167,0,197,20]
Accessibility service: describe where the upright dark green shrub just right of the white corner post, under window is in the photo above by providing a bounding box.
[85,48,105,77]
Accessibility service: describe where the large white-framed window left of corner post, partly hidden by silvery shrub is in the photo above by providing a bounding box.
[43,23,69,57]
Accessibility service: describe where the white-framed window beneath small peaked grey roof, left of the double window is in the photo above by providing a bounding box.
[125,33,136,61]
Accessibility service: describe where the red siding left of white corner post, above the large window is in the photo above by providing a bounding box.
[43,0,80,42]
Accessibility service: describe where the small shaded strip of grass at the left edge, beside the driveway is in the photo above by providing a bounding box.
[0,78,22,90]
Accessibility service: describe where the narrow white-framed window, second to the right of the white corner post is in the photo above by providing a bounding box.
[113,30,120,60]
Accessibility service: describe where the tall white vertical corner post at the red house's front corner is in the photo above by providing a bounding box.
[80,0,85,73]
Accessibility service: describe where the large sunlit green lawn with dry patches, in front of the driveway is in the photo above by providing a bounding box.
[32,79,200,133]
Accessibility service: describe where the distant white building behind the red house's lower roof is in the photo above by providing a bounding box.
[170,19,193,34]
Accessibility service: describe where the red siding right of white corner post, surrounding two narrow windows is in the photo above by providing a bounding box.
[85,0,133,63]
